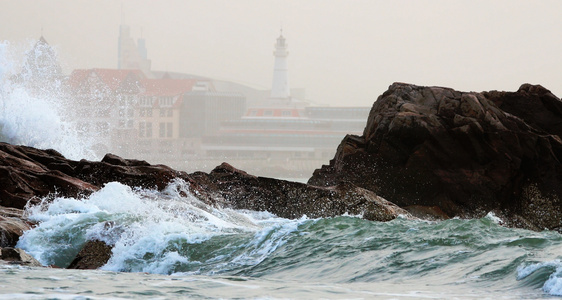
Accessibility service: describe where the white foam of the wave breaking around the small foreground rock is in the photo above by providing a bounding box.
[17,180,306,274]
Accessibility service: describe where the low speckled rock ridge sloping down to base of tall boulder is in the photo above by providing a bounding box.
[191,163,409,221]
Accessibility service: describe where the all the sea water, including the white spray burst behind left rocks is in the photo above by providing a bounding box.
[0,42,562,299]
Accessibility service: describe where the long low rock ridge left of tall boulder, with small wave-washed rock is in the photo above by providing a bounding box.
[0,143,408,268]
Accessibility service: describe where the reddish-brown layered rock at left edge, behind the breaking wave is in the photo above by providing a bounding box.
[0,143,194,246]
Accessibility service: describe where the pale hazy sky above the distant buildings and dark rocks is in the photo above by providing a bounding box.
[0,0,562,106]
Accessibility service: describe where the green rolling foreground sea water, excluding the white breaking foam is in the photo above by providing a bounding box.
[0,217,562,299]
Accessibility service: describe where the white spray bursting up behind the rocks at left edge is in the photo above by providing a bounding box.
[0,42,99,160]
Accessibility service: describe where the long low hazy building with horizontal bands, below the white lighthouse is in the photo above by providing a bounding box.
[202,107,370,162]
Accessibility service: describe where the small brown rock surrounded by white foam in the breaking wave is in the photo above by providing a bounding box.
[67,240,113,270]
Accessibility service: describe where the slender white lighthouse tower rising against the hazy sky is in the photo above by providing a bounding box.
[270,30,291,99]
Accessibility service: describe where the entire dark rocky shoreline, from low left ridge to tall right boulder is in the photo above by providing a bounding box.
[0,83,562,269]
